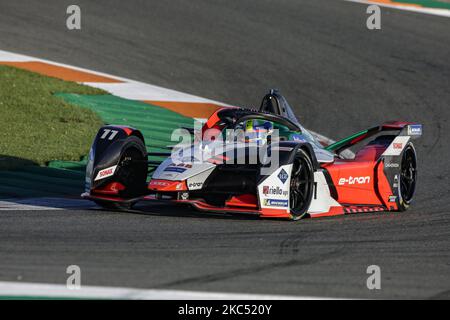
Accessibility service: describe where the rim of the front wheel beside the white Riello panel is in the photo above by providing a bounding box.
[290,158,313,217]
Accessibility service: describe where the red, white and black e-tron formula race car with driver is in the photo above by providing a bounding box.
[82,90,422,220]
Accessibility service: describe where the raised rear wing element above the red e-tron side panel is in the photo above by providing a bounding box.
[325,121,422,154]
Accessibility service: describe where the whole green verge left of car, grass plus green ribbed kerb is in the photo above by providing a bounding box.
[0,66,194,198]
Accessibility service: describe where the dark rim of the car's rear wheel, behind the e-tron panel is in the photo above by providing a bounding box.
[400,148,417,202]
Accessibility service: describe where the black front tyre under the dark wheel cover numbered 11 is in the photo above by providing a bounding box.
[95,136,148,210]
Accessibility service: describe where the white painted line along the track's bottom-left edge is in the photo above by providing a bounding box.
[0,281,333,300]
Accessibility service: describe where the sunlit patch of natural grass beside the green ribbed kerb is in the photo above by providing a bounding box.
[0,66,105,169]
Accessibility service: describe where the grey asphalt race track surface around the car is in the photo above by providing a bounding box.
[0,0,450,298]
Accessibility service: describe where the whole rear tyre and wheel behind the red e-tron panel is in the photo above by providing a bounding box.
[398,142,417,211]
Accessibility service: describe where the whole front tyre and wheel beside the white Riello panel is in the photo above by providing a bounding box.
[289,149,314,220]
